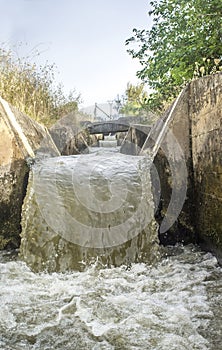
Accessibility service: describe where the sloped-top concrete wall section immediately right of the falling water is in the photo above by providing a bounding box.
[141,87,196,245]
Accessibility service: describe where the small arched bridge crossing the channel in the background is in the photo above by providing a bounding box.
[87,120,130,135]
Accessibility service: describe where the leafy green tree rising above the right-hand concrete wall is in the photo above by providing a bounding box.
[126,0,222,109]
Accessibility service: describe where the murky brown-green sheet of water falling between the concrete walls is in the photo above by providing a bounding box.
[20,149,159,271]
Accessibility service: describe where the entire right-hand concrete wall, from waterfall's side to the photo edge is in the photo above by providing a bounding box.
[142,74,222,263]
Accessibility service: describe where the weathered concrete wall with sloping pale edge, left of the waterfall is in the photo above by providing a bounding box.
[0,98,60,249]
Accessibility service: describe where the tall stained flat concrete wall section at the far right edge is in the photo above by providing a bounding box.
[189,74,222,263]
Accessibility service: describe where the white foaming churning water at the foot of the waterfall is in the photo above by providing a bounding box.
[0,245,222,350]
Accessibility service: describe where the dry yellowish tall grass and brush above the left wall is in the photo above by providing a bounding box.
[0,47,80,126]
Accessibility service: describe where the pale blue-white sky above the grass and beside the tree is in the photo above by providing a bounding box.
[0,0,150,106]
